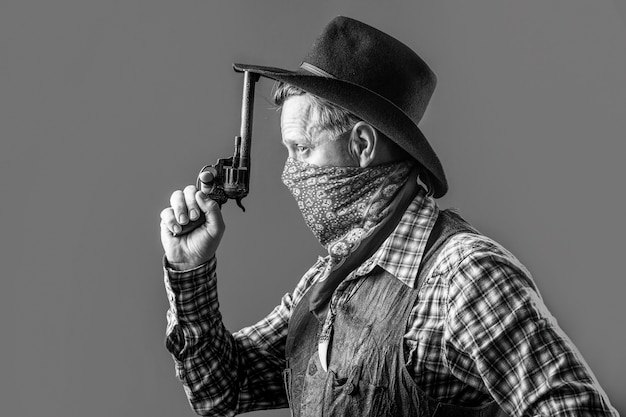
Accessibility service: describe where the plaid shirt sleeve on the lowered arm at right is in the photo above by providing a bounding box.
[444,246,618,416]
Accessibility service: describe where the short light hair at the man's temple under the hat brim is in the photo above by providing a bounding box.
[273,82,361,138]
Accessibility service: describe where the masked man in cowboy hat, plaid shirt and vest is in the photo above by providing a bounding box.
[161,17,617,416]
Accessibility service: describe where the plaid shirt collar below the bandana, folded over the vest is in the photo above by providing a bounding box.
[355,188,439,288]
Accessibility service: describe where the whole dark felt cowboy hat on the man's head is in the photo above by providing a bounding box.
[233,16,448,197]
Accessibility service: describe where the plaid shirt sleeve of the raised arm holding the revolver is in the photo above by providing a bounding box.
[164,258,322,416]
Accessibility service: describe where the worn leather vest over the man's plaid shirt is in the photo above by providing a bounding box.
[284,211,504,417]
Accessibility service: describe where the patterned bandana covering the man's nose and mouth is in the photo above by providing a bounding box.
[282,158,413,250]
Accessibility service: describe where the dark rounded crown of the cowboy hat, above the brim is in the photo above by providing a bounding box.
[302,16,436,123]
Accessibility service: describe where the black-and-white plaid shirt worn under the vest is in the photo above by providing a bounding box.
[165,192,618,416]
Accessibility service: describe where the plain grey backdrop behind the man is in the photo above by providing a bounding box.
[0,0,626,417]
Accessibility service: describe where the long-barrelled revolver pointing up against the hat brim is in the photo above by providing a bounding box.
[174,71,259,236]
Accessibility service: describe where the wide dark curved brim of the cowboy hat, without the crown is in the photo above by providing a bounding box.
[233,63,448,198]
